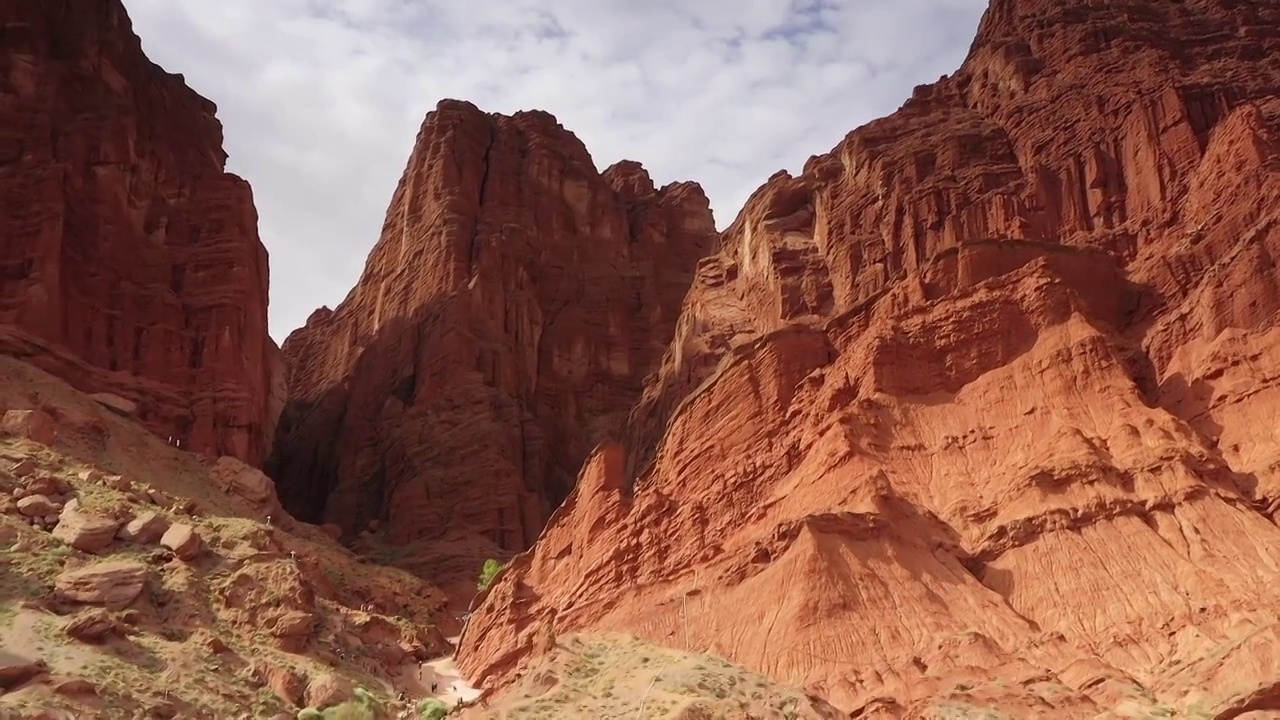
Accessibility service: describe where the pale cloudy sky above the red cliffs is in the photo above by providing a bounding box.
[124,0,987,342]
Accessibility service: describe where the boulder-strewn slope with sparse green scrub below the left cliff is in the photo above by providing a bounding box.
[0,357,457,720]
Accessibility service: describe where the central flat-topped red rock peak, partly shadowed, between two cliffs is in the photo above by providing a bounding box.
[269,101,716,589]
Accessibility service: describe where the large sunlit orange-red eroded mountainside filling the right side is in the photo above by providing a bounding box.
[460,0,1280,717]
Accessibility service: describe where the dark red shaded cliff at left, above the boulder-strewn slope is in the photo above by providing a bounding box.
[0,0,284,464]
